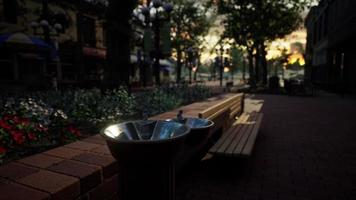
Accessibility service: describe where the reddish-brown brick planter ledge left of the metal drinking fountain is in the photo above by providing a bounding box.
[0,135,118,200]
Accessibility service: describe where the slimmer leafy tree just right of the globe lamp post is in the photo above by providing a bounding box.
[171,0,212,83]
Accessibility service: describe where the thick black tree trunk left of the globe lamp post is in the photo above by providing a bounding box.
[104,0,136,88]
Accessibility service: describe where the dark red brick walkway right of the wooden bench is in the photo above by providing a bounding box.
[176,95,356,200]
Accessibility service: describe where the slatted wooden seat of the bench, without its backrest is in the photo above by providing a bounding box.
[209,112,263,157]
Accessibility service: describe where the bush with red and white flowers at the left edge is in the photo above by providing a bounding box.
[0,98,80,163]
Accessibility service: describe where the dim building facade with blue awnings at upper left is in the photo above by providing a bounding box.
[0,0,106,89]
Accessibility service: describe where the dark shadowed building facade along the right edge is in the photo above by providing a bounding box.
[305,0,356,93]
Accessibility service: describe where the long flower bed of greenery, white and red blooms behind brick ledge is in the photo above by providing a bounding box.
[0,85,211,164]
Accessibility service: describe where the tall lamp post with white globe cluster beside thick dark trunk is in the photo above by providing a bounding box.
[137,0,173,86]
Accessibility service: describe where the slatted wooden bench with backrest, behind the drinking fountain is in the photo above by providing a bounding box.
[199,94,263,156]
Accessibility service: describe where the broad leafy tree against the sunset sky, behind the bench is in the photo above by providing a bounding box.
[218,0,311,84]
